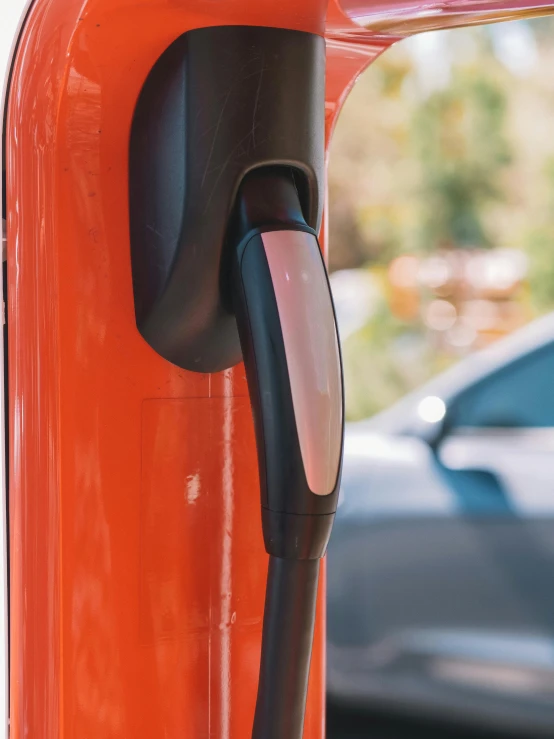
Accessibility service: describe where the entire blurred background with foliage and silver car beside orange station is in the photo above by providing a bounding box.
[328,18,554,739]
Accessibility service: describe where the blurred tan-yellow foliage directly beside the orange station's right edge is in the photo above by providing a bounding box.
[329,50,414,270]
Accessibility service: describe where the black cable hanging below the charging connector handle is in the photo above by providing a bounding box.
[252,557,320,739]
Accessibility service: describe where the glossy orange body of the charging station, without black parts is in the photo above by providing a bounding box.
[6,0,552,739]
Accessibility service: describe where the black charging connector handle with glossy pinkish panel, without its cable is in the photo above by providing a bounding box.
[230,169,343,559]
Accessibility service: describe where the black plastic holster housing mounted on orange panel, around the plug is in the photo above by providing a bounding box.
[129,26,325,372]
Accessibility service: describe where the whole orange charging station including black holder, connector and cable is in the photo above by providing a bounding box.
[4,0,546,739]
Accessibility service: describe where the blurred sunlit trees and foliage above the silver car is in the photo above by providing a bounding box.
[329,18,554,420]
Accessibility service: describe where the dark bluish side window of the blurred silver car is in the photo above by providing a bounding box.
[447,345,554,428]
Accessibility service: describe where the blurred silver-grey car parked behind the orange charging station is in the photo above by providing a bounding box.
[328,315,554,737]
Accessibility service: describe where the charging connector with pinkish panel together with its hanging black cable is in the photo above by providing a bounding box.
[232,168,344,739]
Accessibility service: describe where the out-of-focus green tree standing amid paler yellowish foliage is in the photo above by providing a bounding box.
[412,72,511,251]
